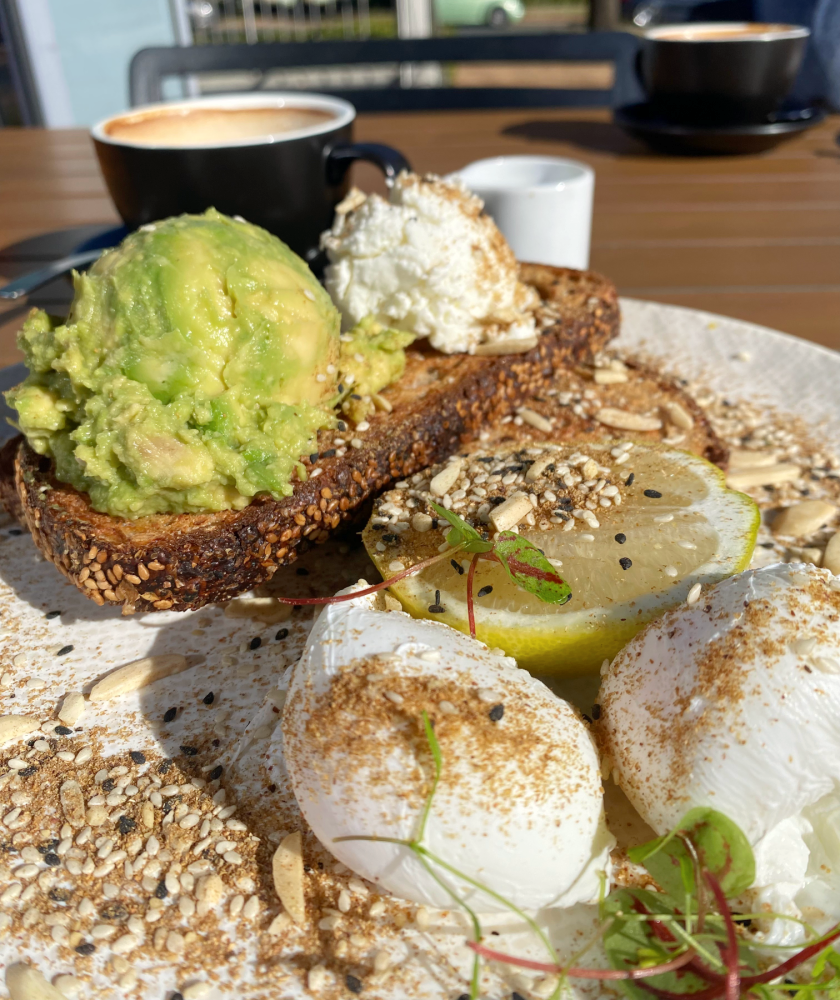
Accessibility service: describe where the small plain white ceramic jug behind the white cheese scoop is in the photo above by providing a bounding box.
[454,156,595,270]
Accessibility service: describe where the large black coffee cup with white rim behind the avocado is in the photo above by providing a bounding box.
[91,92,410,261]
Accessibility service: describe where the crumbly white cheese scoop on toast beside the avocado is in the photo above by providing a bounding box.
[321,173,539,354]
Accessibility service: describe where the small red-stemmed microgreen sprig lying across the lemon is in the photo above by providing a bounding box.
[277,501,572,639]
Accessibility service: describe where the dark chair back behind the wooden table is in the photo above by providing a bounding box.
[129,31,639,111]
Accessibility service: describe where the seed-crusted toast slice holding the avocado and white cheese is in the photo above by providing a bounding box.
[0,264,619,614]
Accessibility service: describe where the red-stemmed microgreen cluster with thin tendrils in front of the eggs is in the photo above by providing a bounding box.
[328,716,840,1000]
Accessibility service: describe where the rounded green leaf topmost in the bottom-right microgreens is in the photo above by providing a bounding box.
[628,806,755,899]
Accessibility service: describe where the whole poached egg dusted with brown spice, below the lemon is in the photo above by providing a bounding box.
[283,584,614,913]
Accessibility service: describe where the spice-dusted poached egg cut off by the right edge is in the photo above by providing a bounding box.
[599,563,840,944]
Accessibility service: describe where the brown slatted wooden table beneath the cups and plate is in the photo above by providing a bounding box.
[0,109,840,365]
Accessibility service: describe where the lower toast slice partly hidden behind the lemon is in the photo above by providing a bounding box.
[482,362,729,468]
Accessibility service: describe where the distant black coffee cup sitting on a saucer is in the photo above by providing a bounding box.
[639,22,810,124]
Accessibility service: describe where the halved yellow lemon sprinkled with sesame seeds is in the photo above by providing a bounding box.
[363,442,759,676]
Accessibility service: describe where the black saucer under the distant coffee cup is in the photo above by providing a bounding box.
[613,103,826,154]
